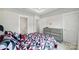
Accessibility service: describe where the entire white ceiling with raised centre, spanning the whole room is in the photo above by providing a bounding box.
[0,8,79,17]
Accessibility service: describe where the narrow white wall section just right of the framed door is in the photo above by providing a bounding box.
[28,15,39,33]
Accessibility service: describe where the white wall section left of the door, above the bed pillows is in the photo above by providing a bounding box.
[0,11,19,32]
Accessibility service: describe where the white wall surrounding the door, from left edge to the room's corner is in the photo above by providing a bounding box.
[0,10,38,33]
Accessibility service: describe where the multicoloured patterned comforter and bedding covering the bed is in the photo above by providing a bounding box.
[0,31,57,50]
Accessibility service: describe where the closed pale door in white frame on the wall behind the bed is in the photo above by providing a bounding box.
[20,17,27,34]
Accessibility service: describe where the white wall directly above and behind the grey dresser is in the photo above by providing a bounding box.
[39,15,63,32]
